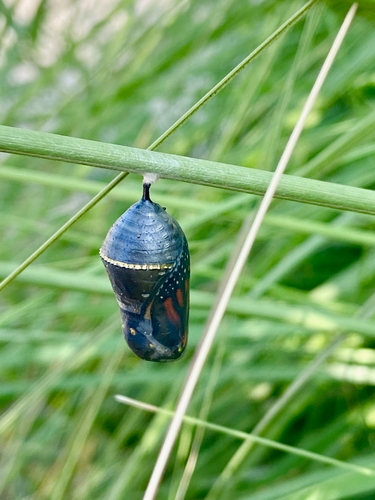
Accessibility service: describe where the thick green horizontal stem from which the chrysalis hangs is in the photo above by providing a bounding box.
[0,126,375,215]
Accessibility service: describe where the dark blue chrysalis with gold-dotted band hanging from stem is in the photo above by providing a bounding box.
[100,184,190,362]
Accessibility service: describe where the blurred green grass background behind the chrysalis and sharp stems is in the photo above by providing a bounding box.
[0,0,375,500]
